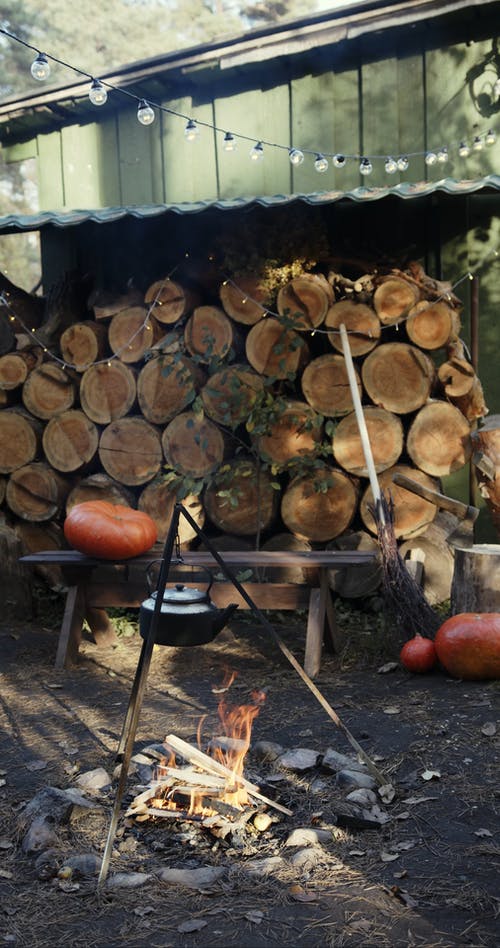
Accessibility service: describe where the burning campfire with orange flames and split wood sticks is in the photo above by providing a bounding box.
[125,674,291,830]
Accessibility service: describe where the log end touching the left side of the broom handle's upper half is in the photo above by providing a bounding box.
[301,354,362,418]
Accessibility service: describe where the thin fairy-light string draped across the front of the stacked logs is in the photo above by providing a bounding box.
[0,247,500,373]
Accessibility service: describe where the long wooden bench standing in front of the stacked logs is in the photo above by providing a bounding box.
[20,547,375,678]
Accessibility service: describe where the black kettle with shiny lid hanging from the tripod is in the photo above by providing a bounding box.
[139,563,238,646]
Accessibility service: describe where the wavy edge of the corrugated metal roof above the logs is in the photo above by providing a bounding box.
[0,174,500,234]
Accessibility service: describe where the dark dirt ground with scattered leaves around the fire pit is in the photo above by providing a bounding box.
[0,592,500,948]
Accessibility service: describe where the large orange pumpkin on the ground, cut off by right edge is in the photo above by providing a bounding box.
[434,612,500,681]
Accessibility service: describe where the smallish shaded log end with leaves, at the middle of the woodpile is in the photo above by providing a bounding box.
[201,365,264,428]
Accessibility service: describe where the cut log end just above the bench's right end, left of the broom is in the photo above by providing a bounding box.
[281,466,358,543]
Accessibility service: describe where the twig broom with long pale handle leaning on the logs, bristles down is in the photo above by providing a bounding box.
[339,323,442,641]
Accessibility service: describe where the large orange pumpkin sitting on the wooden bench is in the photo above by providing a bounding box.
[64,500,158,560]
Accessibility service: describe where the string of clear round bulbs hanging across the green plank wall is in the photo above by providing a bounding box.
[0,27,491,161]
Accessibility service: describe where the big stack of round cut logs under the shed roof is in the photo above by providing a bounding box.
[0,264,487,595]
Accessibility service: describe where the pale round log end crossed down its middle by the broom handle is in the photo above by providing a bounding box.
[332,405,404,477]
